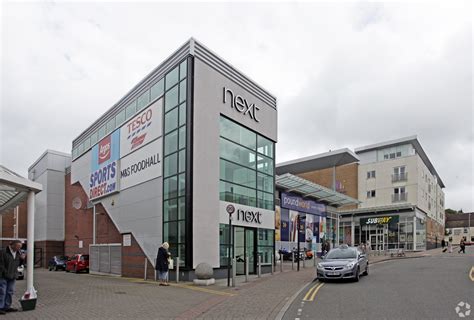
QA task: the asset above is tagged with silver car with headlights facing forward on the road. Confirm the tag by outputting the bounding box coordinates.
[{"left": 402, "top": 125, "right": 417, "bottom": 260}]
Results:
[{"left": 316, "top": 245, "right": 369, "bottom": 281}]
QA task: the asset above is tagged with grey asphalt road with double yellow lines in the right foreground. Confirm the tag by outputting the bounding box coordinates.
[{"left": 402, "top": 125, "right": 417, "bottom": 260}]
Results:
[{"left": 283, "top": 247, "right": 474, "bottom": 320}]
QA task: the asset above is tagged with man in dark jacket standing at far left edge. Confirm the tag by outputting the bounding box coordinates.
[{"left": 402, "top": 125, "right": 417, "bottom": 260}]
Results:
[{"left": 0, "top": 240, "right": 25, "bottom": 314}]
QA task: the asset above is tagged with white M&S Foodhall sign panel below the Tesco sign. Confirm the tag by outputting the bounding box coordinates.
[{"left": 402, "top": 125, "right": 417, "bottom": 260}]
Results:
[{"left": 120, "top": 138, "right": 163, "bottom": 190}]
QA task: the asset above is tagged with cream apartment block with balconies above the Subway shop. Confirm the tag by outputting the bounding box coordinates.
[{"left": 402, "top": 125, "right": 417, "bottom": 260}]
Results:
[{"left": 340, "top": 136, "right": 445, "bottom": 250}]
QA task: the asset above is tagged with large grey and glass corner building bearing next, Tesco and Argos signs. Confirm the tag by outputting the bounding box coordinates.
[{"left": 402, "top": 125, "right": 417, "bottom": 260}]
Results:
[{"left": 70, "top": 39, "right": 277, "bottom": 279}]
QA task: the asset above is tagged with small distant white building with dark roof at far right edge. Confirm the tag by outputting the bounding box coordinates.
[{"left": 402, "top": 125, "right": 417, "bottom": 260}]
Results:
[{"left": 445, "top": 212, "right": 474, "bottom": 244}]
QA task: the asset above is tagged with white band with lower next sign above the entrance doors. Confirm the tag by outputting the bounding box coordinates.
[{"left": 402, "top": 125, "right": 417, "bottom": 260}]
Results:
[{"left": 219, "top": 201, "right": 275, "bottom": 229}]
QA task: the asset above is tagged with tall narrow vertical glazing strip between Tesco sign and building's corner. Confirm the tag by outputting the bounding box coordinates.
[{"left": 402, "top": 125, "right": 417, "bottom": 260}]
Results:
[{"left": 161, "top": 61, "right": 187, "bottom": 266}]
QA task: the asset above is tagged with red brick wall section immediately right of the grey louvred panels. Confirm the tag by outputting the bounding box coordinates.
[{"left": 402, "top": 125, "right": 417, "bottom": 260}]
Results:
[{"left": 122, "top": 234, "right": 154, "bottom": 279}]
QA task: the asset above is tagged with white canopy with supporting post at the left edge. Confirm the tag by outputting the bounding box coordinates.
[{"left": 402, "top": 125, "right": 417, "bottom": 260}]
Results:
[{"left": 0, "top": 165, "right": 43, "bottom": 298}]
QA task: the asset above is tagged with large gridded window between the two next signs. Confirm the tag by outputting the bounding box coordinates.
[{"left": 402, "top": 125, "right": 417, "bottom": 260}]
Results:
[{"left": 220, "top": 116, "right": 275, "bottom": 210}]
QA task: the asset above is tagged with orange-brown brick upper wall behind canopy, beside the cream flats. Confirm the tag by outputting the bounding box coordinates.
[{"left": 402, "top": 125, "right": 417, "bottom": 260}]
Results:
[{"left": 297, "top": 163, "right": 359, "bottom": 210}]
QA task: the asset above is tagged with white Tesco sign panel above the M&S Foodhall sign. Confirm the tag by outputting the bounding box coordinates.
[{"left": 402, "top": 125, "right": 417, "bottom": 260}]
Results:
[{"left": 120, "top": 99, "right": 163, "bottom": 158}]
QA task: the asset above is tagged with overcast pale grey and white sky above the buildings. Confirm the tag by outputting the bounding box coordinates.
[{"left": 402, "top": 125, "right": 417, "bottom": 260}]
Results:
[{"left": 0, "top": 1, "right": 474, "bottom": 212}]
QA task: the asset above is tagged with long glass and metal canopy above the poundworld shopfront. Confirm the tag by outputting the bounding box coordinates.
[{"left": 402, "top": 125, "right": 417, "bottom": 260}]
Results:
[{"left": 275, "top": 173, "right": 360, "bottom": 207}]
